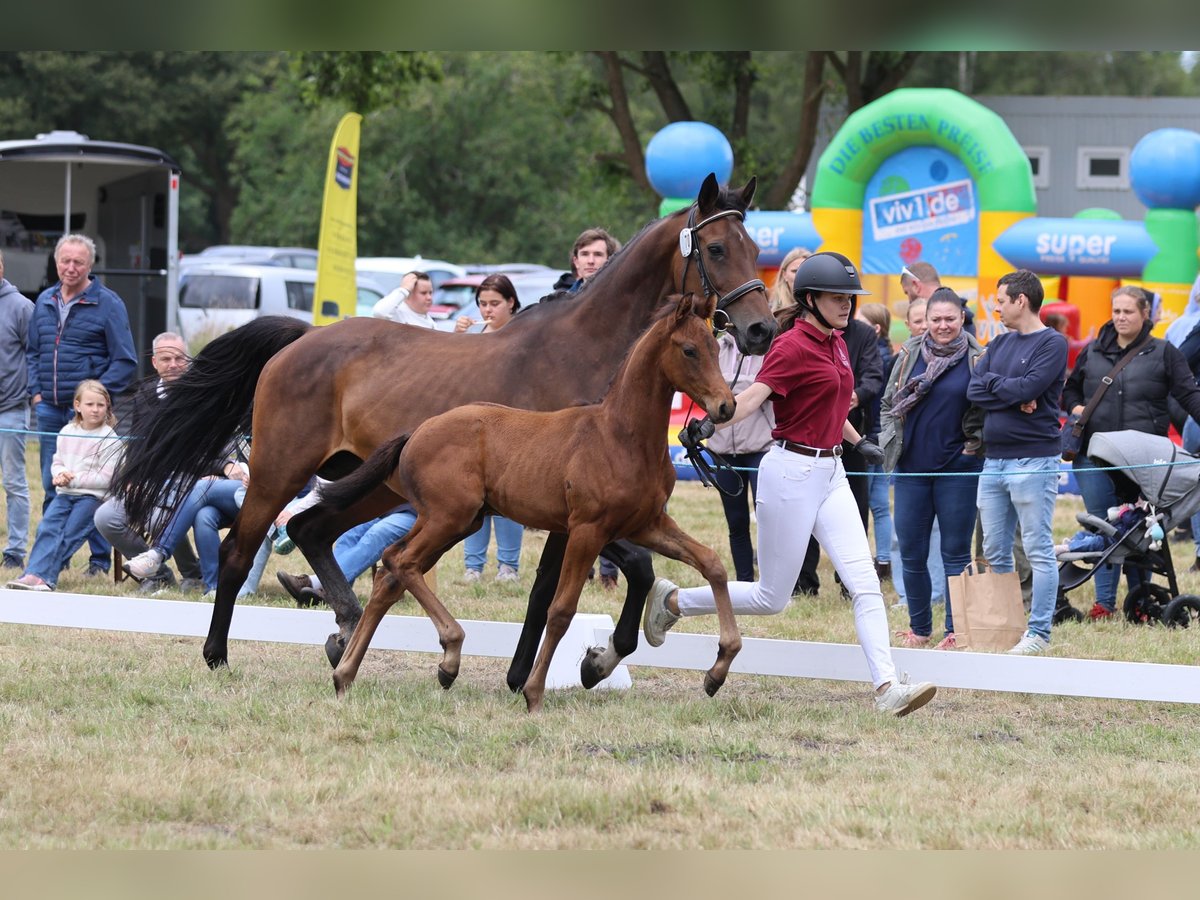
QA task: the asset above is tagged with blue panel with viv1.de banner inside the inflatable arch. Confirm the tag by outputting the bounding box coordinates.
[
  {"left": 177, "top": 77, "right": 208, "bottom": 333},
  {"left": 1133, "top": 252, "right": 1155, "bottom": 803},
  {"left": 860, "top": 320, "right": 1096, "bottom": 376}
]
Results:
[{"left": 862, "top": 146, "right": 979, "bottom": 276}]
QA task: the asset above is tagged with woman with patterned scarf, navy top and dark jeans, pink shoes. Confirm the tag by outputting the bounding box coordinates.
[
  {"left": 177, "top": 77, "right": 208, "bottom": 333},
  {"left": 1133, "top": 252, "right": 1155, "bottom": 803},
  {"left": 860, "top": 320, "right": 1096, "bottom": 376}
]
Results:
[{"left": 880, "top": 288, "right": 984, "bottom": 650}]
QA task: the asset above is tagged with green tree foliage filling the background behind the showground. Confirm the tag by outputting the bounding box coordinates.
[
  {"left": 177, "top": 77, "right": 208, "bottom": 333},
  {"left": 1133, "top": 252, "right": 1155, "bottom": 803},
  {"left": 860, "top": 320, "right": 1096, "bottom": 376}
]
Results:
[{"left": 0, "top": 50, "right": 1200, "bottom": 263}]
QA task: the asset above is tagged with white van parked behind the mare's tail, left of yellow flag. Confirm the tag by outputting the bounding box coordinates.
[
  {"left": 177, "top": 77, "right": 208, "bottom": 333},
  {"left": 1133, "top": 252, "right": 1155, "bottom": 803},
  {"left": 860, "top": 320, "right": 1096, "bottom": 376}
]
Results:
[{"left": 179, "top": 263, "right": 385, "bottom": 354}]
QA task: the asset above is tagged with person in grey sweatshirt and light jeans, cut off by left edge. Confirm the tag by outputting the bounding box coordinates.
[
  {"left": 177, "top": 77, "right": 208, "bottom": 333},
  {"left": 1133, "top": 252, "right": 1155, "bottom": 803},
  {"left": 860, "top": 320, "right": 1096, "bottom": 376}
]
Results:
[{"left": 0, "top": 253, "right": 34, "bottom": 570}]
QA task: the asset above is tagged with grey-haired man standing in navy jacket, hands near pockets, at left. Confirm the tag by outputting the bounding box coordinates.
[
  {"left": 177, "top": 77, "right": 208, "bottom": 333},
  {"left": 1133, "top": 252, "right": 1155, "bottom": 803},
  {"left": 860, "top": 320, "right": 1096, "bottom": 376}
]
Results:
[{"left": 25, "top": 234, "right": 137, "bottom": 575}]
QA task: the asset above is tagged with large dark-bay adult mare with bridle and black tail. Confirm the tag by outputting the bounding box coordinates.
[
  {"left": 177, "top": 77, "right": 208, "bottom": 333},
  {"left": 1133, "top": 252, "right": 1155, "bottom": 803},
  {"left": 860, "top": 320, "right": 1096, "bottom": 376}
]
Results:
[{"left": 116, "top": 175, "right": 776, "bottom": 689}]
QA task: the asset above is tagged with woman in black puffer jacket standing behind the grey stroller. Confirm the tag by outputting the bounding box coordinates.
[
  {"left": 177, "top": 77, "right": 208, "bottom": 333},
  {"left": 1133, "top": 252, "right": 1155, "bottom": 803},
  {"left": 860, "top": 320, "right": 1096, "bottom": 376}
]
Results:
[{"left": 1062, "top": 286, "right": 1200, "bottom": 619}]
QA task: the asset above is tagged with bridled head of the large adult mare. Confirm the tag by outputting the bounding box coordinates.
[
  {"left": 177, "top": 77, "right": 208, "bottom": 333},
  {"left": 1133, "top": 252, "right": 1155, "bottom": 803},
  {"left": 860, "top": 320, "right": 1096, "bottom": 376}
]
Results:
[{"left": 676, "top": 173, "right": 778, "bottom": 355}]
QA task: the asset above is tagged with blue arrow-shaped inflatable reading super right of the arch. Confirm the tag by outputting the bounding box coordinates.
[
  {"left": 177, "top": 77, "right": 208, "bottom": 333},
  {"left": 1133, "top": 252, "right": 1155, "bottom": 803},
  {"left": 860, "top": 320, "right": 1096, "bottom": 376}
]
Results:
[{"left": 992, "top": 218, "right": 1158, "bottom": 277}]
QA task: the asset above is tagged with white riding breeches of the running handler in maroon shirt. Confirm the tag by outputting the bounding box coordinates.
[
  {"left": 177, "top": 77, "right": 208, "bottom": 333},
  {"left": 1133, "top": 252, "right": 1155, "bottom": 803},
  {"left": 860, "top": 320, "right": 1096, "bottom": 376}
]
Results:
[{"left": 678, "top": 446, "right": 896, "bottom": 688}]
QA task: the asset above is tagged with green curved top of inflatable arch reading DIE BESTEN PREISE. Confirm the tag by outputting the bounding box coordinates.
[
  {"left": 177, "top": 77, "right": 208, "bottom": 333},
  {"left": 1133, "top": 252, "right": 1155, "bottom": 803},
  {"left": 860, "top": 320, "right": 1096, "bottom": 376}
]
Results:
[{"left": 812, "top": 88, "right": 1037, "bottom": 214}]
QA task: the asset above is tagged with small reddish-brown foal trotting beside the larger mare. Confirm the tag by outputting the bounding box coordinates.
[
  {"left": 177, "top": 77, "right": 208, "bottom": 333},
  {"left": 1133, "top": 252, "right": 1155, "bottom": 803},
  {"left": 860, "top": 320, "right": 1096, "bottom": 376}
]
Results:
[{"left": 326, "top": 295, "right": 742, "bottom": 712}]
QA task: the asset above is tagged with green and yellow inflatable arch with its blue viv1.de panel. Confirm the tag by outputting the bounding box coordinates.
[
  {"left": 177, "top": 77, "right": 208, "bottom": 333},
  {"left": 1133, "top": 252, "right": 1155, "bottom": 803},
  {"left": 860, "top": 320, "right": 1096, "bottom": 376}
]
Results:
[{"left": 812, "top": 88, "right": 1037, "bottom": 338}]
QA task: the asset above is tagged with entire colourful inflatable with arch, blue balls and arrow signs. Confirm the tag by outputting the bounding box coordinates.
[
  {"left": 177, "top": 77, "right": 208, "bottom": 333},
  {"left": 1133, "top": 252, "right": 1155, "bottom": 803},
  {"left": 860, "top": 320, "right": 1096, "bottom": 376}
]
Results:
[{"left": 646, "top": 88, "right": 1200, "bottom": 341}]
